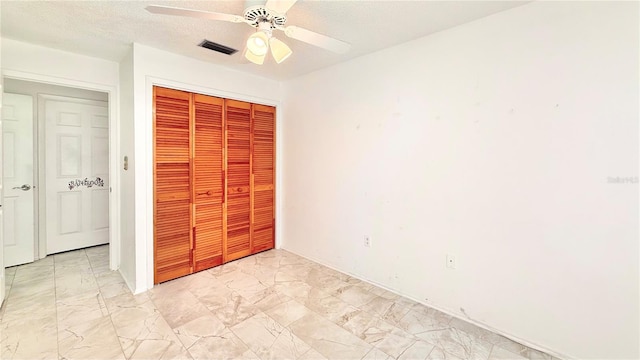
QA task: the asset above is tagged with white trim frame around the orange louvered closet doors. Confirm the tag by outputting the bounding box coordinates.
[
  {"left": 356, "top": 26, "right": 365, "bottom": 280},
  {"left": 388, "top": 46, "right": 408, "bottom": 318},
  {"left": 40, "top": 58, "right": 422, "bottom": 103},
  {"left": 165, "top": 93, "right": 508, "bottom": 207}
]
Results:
[{"left": 145, "top": 76, "right": 283, "bottom": 290}]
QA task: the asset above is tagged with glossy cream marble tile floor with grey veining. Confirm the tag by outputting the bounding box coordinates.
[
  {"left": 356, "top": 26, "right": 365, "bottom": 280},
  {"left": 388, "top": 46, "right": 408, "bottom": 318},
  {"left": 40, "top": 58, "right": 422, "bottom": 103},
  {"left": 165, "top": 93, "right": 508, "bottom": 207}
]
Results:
[{"left": 0, "top": 246, "right": 554, "bottom": 360}]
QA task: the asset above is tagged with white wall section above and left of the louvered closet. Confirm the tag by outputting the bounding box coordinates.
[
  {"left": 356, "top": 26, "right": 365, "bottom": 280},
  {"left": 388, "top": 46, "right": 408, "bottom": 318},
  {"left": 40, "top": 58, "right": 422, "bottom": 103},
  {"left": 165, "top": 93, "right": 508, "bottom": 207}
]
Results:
[{"left": 129, "top": 44, "right": 281, "bottom": 292}]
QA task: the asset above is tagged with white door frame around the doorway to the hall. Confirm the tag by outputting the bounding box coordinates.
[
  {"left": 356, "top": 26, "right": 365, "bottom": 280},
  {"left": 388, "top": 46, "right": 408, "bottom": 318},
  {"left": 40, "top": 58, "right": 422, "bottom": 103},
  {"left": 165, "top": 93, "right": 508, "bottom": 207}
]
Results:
[{"left": 2, "top": 70, "right": 121, "bottom": 270}]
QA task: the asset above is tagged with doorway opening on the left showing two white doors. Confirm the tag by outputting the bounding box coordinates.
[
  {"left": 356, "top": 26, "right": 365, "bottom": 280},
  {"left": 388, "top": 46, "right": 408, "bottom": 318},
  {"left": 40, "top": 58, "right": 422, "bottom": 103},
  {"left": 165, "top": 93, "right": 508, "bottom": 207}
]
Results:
[{"left": 3, "top": 78, "right": 112, "bottom": 268}]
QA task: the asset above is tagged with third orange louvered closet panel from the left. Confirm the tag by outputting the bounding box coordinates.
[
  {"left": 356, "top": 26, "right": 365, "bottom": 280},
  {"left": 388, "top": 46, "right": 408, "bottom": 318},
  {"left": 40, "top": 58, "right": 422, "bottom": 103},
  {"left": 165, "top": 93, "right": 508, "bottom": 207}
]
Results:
[{"left": 225, "top": 100, "right": 251, "bottom": 262}]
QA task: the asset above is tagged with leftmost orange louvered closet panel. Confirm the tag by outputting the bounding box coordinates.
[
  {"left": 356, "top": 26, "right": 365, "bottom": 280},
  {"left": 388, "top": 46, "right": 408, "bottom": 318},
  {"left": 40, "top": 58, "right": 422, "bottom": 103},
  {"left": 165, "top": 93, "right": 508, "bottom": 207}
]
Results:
[{"left": 153, "top": 87, "right": 191, "bottom": 283}]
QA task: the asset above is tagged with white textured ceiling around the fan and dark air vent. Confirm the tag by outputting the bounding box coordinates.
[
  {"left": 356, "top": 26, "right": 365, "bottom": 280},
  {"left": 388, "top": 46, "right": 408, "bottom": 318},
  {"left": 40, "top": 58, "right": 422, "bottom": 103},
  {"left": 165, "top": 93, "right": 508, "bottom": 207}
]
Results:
[{"left": 0, "top": 0, "right": 527, "bottom": 80}]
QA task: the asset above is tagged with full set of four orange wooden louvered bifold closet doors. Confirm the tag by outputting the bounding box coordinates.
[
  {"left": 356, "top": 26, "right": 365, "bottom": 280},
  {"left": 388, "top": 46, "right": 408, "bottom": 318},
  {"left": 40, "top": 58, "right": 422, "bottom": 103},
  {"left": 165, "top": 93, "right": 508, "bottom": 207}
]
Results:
[{"left": 153, "top": 87, "right": 275, "bottom": 283}]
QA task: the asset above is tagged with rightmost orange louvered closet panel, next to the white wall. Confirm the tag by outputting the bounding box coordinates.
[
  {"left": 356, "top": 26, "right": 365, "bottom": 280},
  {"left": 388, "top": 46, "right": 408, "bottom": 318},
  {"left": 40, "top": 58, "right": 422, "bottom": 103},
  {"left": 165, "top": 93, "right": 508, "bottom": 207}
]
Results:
[{"left": 251, "top": 104, "right": 275, "bottom": 253}]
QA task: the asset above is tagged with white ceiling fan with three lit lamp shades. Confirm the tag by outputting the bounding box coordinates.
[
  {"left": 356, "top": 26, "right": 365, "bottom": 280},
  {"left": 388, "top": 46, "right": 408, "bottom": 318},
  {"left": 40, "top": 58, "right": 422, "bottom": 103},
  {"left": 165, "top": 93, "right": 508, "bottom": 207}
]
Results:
[{"left": 146, "top": 0, "right": 351, "bottom": 65}]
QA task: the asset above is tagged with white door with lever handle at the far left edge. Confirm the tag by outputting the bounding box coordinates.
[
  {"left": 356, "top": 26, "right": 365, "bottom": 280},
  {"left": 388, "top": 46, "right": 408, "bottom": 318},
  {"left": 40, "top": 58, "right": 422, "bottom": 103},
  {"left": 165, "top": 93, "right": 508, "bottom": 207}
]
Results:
[{"left": 2, "top": 93, "right": 35, "bottom": 266}]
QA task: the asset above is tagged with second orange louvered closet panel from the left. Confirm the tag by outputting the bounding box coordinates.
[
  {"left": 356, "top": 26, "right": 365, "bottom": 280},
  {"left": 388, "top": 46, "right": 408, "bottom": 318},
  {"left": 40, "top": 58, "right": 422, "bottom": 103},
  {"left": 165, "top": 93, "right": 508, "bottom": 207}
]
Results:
[{"left": 193, "top": 94, "right": 224, "bottom": 271}]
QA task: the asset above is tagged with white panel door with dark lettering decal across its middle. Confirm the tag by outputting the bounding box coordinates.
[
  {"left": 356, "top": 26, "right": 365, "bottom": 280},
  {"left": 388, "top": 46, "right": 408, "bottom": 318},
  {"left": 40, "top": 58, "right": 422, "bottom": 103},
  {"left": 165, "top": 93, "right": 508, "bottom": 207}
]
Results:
[{"left": 42, "top": 95, "right": 109, "bottom": 254}]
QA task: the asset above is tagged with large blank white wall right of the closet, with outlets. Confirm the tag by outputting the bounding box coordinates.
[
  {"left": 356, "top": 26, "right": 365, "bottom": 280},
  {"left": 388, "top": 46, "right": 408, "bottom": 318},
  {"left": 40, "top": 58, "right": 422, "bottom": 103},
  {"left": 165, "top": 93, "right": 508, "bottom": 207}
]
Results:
[{"left": 282, "top": 2, "right": 640, "bottom": 359}]
